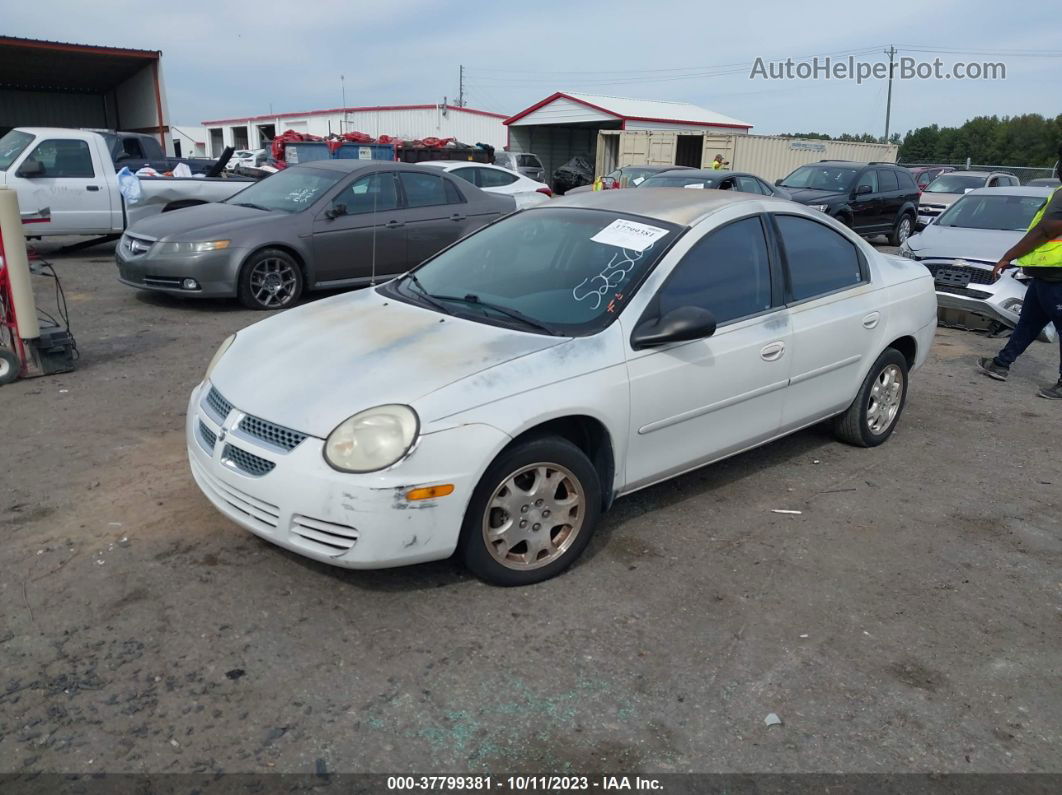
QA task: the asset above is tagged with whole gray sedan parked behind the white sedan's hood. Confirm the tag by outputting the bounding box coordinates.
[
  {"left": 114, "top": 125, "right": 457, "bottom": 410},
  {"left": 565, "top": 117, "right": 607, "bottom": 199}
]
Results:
[{"left": 115, "top": 160, "right": 516, "bottom": 309}]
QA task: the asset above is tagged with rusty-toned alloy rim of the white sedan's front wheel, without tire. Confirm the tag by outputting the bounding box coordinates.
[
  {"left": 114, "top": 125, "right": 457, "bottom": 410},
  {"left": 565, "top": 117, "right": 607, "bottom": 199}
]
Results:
[{"left": 482, "top": 463, "right": 586, "bottom": 570}]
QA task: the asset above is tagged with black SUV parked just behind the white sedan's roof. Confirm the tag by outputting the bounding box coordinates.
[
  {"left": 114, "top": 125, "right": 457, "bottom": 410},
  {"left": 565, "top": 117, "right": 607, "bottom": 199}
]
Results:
[{"left": 775, "top": 160, "right": 919, "bottom": 245}]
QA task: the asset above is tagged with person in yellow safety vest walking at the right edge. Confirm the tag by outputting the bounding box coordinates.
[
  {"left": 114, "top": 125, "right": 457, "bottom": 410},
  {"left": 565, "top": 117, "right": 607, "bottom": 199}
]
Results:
[{"left": 977, "top": 148, "right": 1062, "bottom": 400}]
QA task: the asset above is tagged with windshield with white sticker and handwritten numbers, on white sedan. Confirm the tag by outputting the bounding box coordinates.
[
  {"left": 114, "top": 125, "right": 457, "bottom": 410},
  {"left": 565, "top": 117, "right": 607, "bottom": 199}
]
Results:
[{"left": 389, "top": 208, "right": 680, "bottom": 336}]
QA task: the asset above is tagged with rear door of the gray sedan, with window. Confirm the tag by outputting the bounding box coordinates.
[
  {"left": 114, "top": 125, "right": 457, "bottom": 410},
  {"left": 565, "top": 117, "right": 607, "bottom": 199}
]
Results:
[{"left": 398, "top": 171, "right": 473, "bottom": 267}]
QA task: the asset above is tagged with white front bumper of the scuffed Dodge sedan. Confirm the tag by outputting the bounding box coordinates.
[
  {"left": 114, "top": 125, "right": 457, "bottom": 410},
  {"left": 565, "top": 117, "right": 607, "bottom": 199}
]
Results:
[{"left": 185, "top": 382, "right": 510, "bottom": 569}]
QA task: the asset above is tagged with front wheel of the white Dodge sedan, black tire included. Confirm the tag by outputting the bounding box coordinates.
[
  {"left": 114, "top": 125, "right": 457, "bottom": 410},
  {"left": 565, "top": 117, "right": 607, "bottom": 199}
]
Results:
[{"left": 458, "top": 436, "right": 601, "bottom": 586}]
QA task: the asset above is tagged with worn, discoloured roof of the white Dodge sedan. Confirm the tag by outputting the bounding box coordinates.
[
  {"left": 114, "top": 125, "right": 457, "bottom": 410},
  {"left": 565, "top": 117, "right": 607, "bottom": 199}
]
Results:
[{"left": 547, "top": 188, "right": 792, "bottom": 226}]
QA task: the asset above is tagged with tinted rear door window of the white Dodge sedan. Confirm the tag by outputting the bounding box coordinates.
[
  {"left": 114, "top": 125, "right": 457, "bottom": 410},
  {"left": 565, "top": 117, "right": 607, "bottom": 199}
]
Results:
[{"left": 774, "top": 214, "right": 864, "bottom": 301}]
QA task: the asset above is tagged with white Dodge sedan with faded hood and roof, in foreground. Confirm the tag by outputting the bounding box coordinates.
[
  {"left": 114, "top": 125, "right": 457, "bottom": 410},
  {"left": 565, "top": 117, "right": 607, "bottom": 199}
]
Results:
[{"left": 187, "top": 189, "right": 937, "bottom": 585}]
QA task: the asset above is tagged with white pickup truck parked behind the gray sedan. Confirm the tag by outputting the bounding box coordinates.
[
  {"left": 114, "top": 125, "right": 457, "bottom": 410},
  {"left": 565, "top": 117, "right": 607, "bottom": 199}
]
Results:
[{"left": 0, "top": 127, "right": 255, "bottom": 237}]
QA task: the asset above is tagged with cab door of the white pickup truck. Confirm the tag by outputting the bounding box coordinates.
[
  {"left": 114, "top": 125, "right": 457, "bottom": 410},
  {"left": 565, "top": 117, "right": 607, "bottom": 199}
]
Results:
[{"left": 11, "top": 138, "right": 110, "bottom": 235}]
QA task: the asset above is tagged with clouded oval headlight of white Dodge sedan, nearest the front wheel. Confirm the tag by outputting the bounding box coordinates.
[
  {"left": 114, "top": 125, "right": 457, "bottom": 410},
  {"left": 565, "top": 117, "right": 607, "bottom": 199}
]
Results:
[{"left": 325, "top": 404, "right": 421, "bottom": 472}]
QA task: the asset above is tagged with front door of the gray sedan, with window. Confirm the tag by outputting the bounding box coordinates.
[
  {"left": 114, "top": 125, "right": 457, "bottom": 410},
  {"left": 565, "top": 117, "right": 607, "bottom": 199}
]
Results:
[{"left": 313, "top": 171, "right": 407, "bottom": 284}]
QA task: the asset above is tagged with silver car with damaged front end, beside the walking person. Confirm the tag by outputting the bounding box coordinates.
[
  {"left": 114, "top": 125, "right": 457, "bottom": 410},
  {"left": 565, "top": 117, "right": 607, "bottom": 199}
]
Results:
[{"left": 900, "top": 185, "right": 1056, "bottom": 342}]
